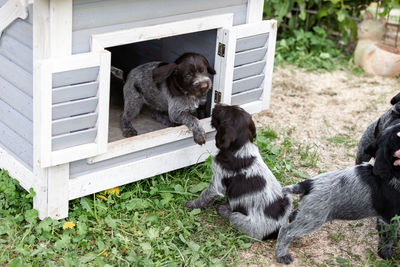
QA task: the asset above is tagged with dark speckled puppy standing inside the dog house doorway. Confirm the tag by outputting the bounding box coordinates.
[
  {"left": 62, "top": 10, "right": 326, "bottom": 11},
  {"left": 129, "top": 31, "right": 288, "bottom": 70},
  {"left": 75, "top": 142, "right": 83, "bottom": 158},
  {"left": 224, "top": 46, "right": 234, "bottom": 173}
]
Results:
[{"left": 121, "top": 53, "right": 215, "bottom": 145}]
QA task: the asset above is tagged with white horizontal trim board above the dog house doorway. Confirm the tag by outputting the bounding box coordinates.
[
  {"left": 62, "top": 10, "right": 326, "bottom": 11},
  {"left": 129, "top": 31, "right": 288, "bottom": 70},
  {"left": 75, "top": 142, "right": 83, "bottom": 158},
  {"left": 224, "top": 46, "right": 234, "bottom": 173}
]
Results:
[{"left": 91, "top": 14, "right": 233, "bottom": 51}]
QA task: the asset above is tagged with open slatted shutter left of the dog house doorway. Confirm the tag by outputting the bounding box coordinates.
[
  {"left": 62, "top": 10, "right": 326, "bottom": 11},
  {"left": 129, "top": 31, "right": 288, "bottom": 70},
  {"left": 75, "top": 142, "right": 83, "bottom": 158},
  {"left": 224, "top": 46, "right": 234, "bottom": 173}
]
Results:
[{"left": 35, "top": 50, "right": 111, "bottom": 168}]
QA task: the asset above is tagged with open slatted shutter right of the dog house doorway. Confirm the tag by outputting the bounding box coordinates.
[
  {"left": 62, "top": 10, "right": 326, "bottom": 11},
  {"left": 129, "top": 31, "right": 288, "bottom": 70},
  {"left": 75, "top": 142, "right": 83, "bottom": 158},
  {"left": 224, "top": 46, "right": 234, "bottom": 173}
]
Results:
[{"left": 220, "top": 20, "right": 277, "bottom": 113}]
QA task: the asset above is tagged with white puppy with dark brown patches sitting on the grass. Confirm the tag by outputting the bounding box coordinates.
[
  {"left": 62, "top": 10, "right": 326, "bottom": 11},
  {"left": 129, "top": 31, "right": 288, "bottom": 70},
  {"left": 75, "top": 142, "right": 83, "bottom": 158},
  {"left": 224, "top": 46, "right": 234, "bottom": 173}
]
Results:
[{"left": 185, "top": 105, "right": 292, "bottom": 240}]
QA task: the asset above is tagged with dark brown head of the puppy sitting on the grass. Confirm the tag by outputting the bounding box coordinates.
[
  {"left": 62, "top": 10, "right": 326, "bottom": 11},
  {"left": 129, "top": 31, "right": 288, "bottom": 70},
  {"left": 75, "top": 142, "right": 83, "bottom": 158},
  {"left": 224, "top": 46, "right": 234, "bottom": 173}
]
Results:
[{"left": 211, "top": 105, "right": 256, "bottom": 151}]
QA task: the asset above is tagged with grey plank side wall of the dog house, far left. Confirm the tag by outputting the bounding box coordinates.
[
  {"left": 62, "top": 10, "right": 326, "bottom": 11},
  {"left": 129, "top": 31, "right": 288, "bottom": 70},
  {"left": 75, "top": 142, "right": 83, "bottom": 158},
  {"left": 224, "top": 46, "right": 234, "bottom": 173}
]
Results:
[{"left": 0, "top": 0, "right": 33, "bottom": 169}]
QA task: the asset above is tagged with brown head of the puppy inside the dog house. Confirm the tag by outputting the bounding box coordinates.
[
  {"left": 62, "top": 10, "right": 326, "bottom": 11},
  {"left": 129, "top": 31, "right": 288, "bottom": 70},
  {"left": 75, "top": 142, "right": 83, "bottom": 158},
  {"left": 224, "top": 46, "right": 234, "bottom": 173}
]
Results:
[{"left": 153, "top": 53, "right": 216, "bottom": 98}]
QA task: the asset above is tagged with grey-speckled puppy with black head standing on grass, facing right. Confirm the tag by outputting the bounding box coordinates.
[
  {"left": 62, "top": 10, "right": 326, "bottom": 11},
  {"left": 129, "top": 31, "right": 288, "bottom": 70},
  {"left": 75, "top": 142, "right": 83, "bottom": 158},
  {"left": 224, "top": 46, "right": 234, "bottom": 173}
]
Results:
[{"left": 275, "top": 120, "right": 400, "bottom": 264}]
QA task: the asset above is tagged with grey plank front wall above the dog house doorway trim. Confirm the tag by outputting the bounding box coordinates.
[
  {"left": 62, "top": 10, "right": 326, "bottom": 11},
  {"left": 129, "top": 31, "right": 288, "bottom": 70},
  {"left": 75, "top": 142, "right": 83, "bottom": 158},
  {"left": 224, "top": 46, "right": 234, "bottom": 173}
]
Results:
[{"left": 72, "top": 0, "right": 247, "bottom": 54}]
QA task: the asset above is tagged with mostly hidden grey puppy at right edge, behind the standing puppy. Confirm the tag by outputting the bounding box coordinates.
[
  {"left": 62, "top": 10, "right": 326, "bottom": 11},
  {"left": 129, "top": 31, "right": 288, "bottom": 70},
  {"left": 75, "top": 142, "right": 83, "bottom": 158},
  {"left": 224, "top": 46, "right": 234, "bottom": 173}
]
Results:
[{"left": 356, "top": 93, "right": 400, "bottom": 164}]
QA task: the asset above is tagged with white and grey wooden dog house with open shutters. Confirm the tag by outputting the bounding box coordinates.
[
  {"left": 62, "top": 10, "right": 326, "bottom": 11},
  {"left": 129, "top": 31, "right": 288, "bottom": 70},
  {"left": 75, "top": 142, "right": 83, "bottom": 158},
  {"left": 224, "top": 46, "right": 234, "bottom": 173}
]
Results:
[{"left": 0, "top": 0, "right": 277, "bottom": 219}]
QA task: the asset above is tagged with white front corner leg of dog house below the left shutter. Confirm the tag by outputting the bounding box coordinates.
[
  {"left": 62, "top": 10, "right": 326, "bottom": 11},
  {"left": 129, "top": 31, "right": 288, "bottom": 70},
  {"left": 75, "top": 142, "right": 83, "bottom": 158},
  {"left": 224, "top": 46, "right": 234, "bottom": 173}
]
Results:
[{"left": 47, "top": 164, "right": 69, "bottom": 220}]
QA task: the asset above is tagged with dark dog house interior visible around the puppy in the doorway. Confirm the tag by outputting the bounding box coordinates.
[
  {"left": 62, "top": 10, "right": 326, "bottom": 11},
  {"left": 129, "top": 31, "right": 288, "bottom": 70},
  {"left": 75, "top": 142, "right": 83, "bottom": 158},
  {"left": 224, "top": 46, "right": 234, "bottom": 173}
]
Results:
[{"left": 107, "top": 30, "right": 217, "bottom": 142}]
